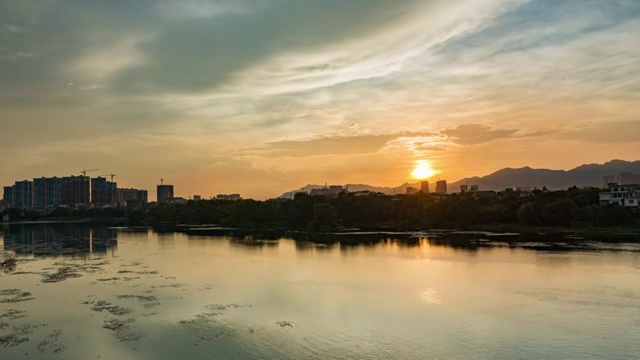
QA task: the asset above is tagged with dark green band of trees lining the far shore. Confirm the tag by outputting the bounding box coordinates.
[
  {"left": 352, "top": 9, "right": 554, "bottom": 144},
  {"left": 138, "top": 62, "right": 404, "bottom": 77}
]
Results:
[{"left": 2, "top": 187, "right": 640, "bottom": 238}]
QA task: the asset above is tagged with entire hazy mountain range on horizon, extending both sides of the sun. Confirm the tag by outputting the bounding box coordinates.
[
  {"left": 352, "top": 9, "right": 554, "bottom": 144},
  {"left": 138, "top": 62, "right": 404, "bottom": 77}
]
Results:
[{"left": 280, "top": 160, "right": 640, "bottom": 199}]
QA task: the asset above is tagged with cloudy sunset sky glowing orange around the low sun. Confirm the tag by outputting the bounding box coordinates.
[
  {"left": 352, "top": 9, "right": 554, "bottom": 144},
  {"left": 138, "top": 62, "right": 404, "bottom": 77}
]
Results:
[{"left": 0, "top": 0, "right": 640, "bottom": 199}]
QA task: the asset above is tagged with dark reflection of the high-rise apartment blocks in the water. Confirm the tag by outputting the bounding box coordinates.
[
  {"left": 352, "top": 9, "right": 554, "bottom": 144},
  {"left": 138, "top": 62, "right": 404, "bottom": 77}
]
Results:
[{"left": 4, "top": 224, "right": 117, "bottom": 257}]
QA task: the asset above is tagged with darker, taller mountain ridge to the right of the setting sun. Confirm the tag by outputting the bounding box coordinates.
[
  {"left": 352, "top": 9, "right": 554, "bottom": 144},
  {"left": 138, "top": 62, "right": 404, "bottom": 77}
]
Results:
[{"left": 448, "top": 160, "right": 640, "bottom": 192}]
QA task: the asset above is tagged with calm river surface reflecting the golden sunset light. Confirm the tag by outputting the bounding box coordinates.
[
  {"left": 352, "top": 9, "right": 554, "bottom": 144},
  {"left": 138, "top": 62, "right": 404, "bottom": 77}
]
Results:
[{"left": 0, "top": 224, "right": 640, "bottom": 359}]
